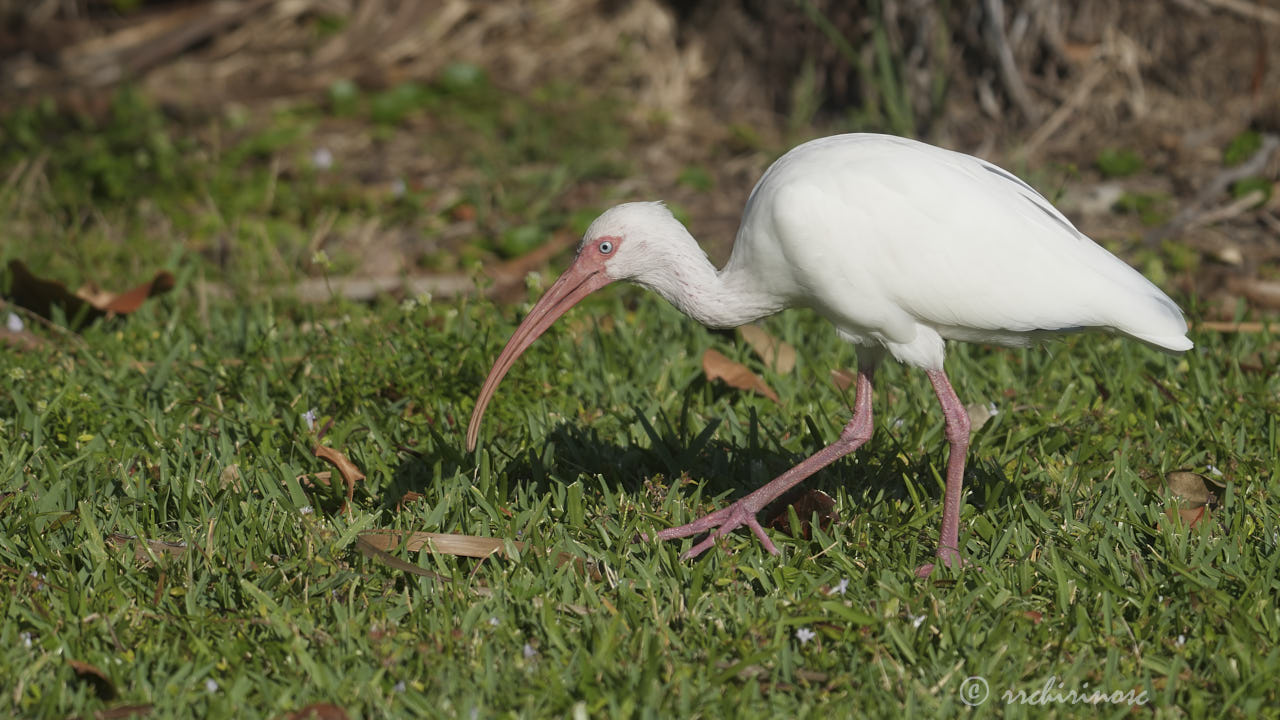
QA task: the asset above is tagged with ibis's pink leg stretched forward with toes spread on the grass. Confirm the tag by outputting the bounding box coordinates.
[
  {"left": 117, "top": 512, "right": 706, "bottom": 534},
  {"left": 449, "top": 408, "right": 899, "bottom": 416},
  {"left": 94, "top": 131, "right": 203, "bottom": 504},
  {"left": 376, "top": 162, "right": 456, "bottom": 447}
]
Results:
[{"left": 658, "top": 364, "right": 875, "bottom": 559}]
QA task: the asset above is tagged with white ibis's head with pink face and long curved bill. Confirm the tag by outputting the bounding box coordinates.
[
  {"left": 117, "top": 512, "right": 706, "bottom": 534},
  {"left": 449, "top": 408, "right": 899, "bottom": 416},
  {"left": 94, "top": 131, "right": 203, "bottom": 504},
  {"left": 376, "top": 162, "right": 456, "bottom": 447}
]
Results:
[{"left": 467, "top": 202, "right": 696, "bottom": 450}]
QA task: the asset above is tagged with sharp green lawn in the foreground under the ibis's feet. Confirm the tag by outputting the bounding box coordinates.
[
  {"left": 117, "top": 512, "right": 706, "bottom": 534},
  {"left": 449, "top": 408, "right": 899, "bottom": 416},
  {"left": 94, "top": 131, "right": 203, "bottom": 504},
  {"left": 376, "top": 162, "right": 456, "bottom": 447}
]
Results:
[{"left": 0, "top": 278, "right": 1280, "bottom": 717}]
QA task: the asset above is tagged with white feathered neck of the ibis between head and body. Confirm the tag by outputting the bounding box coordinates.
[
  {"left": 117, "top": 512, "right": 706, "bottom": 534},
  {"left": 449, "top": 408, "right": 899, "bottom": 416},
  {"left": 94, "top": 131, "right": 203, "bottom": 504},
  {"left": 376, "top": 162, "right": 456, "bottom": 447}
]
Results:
[{"left": 637, "top": 237, "right": 786, "bottom": 328}]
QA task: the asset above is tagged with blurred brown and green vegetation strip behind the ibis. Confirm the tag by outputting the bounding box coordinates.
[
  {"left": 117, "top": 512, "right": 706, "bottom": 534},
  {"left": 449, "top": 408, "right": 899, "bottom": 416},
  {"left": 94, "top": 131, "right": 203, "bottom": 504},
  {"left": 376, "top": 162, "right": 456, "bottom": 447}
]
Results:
[{"left": 0, "top": 0, "right": 1280, "bottom": 318}]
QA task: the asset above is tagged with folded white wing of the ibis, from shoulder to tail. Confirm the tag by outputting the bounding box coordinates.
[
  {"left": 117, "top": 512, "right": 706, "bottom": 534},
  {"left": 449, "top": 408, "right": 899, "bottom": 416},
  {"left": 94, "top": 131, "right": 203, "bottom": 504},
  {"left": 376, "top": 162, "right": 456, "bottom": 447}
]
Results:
[{"left": 768, "top": 138, "right": 1190, "bottom": 350}]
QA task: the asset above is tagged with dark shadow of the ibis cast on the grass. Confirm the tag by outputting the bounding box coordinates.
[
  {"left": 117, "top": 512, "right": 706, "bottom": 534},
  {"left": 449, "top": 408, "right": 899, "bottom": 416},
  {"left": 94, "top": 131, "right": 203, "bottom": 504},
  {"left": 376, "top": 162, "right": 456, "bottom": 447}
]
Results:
[{"left": 381, "top": 392, "right": 1023, "bottom": 543}]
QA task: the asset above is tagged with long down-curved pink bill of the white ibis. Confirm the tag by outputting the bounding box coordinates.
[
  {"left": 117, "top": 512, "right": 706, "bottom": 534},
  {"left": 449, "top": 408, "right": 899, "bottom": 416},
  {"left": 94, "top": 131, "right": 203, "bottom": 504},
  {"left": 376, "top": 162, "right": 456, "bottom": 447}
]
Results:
[{"left": 467, "top": 255, "right": 613, "bottom": 452}]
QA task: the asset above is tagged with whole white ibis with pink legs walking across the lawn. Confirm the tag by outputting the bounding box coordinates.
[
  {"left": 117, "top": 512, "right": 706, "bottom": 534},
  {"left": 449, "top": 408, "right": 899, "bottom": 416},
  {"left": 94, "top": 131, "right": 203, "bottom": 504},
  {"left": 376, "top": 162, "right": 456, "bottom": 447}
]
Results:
[{"left": 467, "top": 135, "right": 1192, "bottom": 575}]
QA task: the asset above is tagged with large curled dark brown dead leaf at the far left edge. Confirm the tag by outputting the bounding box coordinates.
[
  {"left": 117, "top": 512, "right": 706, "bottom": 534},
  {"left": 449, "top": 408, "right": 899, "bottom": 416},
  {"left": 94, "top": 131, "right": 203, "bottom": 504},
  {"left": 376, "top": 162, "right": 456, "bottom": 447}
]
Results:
[{"left": 9, "top": 260, "right": 175, "bottom": 320}]
